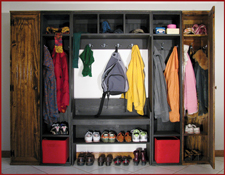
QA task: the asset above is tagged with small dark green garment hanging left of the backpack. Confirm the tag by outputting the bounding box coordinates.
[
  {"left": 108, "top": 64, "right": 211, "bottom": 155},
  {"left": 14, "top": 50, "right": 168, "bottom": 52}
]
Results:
[{"left": 80, "top": 44, "right": 95, "bottom": 77}]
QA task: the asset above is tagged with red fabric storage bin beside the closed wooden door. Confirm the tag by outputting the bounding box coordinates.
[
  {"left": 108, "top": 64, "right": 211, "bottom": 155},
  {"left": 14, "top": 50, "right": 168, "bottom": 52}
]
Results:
[{"left": 42, "top": 138, "right": 69, "bottom": 164}]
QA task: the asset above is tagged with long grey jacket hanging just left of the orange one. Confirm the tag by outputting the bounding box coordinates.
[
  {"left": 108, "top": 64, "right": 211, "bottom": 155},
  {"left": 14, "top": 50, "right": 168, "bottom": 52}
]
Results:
[{"left": 153, "top": 46, "right": 171, "bottom": 122}]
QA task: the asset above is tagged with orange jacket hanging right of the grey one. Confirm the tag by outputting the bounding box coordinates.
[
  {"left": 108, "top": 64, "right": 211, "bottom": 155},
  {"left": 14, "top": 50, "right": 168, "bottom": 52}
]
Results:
[{"left": 164, "top": 46, "right": 180, "bottom": 122}]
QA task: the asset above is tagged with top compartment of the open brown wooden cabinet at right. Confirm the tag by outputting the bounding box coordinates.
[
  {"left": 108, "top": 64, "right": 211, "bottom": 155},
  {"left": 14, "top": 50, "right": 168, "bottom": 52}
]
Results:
[{"left": 182, "top": 11, "right": 209, "bottom": 35}]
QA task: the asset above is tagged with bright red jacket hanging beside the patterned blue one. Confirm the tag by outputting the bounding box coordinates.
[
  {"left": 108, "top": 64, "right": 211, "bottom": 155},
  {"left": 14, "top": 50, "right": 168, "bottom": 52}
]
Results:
[{"left": 52, "top": 47, "right": 70, "bottom": 113}]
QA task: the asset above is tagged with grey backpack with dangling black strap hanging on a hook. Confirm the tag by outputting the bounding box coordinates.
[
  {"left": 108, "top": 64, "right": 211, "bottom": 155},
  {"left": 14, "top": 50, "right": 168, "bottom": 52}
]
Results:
[{"left": 95, "top": 50, "right": 129, "bottom": 117}]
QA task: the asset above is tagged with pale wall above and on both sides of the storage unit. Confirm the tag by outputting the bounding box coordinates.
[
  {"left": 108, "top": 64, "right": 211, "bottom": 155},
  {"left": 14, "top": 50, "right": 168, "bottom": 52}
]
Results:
[{"left": 1, "top": 1, "right": 224, "bottom": 151}]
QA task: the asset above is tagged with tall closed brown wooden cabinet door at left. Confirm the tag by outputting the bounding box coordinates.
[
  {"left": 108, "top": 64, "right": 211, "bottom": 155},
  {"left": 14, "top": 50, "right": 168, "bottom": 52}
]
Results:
[{"left": 10, "top": 12, "right": 40, "bottom": 164}]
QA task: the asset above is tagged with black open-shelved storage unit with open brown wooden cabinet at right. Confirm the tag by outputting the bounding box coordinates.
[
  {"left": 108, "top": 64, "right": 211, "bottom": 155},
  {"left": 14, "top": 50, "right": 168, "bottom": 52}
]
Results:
[{"left": 11, "top": 7, "right": 215, "bottom": 168}]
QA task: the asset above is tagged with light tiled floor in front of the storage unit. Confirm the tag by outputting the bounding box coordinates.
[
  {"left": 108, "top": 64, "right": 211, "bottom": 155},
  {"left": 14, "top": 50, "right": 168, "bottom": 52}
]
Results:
[{"left": 2, "top": 157, "right": 224, "bottom": 174}]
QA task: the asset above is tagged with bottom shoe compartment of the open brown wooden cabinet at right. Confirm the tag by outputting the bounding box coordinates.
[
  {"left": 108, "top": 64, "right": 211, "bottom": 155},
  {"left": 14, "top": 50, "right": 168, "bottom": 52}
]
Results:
[{"left": 183, "top": 135, "right": 209, "bottom": 163}]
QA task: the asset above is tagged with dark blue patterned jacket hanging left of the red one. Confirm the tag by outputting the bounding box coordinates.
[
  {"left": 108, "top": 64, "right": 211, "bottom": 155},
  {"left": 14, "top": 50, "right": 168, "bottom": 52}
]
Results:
[{"left": 43, "top": 46, "right": 59, "bottom": 126}]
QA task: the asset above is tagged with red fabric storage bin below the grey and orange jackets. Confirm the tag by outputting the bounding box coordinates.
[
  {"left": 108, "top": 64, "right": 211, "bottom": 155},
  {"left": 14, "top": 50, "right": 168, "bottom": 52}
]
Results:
[{"left": 155, "top": 137, "right": 180, "bottom": 163}]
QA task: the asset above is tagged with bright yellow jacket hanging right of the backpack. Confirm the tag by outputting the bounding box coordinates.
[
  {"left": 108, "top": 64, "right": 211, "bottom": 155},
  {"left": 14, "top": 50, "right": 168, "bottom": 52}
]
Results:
[{"left": 121, "top": 45, "right": 146, "bottom": 115}]
